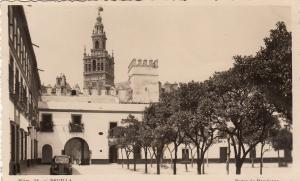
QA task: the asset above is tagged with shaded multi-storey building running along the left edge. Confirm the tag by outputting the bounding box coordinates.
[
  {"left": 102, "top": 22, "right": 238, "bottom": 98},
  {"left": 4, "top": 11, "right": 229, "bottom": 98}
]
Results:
[{"left": 8, "top": 6, "right": 41, "bottom": 174}]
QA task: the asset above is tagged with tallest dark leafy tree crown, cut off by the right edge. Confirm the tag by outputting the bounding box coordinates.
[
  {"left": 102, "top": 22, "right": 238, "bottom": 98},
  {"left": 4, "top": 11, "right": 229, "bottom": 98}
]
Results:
[{"left": 234, "top": 22, "right": 292, "bottom": 124}]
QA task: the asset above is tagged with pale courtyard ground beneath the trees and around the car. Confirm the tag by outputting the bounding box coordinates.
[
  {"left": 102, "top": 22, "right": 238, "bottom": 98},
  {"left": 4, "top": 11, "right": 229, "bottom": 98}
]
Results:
[{"left": 21, "top": 163, "right": 293, "bottom": 175}]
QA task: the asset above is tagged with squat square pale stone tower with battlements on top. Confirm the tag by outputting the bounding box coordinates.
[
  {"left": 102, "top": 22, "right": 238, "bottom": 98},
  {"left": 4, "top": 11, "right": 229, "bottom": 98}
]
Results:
[{"left": 128, "top": 59, "right": 159, "bottom": 103}]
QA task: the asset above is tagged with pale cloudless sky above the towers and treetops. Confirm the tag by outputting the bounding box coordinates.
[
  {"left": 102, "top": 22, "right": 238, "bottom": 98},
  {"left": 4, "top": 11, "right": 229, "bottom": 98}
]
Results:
[{"left": 24, "top": 5, "right": 291, "bottom": 87}]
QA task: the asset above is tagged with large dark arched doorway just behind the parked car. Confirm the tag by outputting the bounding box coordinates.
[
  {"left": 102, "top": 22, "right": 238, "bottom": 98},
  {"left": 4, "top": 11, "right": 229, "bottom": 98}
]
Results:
[{"left": 64, "top": 137, "right": 90, "bottom": 165}]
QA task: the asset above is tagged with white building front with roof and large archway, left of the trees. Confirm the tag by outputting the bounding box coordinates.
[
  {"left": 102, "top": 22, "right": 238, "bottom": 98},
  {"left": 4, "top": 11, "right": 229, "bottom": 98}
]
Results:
[{"left": 38, "top": 95, "right": 146, "bottom": 164}]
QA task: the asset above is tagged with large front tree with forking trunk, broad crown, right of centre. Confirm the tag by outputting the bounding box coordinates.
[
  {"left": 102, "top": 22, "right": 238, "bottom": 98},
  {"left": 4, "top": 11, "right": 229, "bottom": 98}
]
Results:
[{"left": 211, "top": 69, "right": 278, "bottom": 174}]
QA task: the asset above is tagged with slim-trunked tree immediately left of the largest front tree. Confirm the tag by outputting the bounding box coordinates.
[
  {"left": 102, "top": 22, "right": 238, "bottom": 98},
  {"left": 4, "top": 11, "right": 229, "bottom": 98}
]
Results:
[{"left": 178, "top": 81, "right": 218, "bottom": 174}]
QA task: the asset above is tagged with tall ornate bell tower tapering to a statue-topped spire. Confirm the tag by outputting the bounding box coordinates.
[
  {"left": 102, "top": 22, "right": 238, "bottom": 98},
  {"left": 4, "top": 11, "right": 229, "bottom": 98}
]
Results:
[{"left": 83, "top": 7, "right": 114, "bottom": 95}]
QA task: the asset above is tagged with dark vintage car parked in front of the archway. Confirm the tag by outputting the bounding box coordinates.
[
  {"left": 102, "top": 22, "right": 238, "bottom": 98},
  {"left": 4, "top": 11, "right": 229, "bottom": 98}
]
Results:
[{"left": 50, "top": 155, "right": 72, "bottom": 175}]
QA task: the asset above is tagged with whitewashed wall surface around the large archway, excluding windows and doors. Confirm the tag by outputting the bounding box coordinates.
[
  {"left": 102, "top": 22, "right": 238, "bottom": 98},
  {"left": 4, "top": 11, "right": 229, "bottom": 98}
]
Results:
[{"left": 38, "top": 111, "right": 141, "bottom": 163}]
